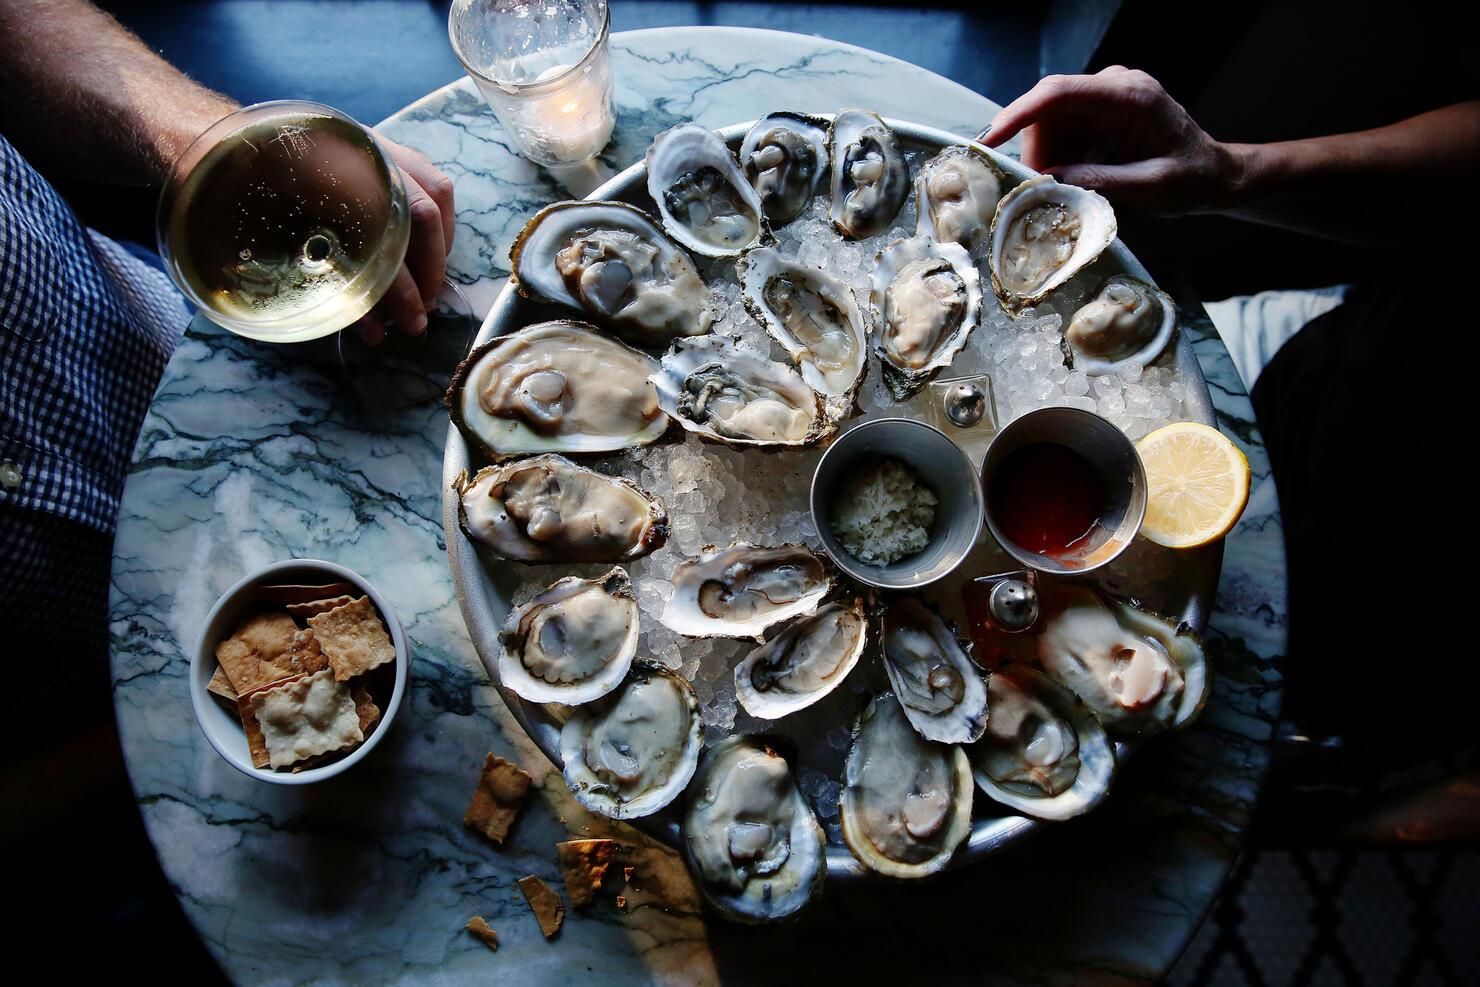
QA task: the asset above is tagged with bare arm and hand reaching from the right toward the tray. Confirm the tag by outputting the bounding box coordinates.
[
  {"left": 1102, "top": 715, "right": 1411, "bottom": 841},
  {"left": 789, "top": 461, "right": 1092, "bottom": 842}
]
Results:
[{"left": 987, "top": 65, "right": 1480, "bottom": 246}]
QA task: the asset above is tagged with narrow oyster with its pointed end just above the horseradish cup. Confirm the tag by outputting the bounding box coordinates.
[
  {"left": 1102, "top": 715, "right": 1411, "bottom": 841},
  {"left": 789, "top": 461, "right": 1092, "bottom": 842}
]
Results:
[{"left": 736, "top": 247, "right": 869, "bottom": 417}]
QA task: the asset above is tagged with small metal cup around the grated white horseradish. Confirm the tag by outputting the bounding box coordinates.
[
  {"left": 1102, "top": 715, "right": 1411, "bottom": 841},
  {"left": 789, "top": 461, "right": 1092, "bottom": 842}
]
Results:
[{"left": 811, "top": 419, "right": 981, "bottom": 589}]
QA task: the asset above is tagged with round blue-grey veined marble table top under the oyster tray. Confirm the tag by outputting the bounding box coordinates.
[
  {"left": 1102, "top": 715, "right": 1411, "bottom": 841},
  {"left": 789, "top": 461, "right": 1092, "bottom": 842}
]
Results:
[{"left": 111, "top": 28, "right": 1285, "bottom": 984}]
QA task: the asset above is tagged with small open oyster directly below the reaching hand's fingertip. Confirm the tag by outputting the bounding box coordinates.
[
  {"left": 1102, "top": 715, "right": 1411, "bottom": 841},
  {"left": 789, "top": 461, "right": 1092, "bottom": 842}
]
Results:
[{"left": 915, "top": 144, "right": 1011, "bottom": 255}]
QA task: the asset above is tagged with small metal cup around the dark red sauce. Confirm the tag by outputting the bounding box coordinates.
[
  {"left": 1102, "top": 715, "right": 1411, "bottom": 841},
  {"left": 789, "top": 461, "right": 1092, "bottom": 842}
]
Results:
[{"left": 981, "top": 408, "right": 1146, "bottom": 576}]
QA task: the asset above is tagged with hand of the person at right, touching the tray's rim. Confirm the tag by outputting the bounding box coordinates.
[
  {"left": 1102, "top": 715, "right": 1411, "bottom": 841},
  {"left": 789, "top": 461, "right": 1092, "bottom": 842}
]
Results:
[{"left": 984, "top": 65, "right": 1240, "bottom": 215}]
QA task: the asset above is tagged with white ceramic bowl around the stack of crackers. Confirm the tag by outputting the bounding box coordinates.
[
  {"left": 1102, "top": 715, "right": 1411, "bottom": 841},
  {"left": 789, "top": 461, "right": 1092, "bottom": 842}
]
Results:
[{"left": 189, "top": 559, "right": 411, "bottom": 784}]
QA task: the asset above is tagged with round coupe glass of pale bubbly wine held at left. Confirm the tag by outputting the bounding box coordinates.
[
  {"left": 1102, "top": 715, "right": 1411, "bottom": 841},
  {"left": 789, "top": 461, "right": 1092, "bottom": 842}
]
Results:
[{"left": 155, "top": 99, "right": 411, "bottom": 342}]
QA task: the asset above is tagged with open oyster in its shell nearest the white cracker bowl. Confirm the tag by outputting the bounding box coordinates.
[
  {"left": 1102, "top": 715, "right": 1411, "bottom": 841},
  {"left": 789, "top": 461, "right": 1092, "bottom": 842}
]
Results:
[{"left": 499, "top": 567, "right": 638, "bottom": 706}]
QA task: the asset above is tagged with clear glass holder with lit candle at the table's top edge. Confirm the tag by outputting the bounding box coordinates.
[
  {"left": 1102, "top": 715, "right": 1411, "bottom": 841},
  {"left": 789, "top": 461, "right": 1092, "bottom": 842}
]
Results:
[{"left": 447, "top": 0, "right": 614, "bottom": 167}]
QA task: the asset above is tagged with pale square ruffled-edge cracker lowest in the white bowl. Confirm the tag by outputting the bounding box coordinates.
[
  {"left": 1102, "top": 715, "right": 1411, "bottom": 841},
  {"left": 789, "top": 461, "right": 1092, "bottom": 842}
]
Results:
[{"left": 252, "top": 669, "right": 364, "bottom": 768}]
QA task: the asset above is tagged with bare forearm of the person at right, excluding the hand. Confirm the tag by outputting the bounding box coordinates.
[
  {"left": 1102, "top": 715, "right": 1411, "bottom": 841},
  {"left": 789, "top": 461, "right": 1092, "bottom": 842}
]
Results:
[{"left": 1221, "top": 101, "right": 1480, "bottom": 249}]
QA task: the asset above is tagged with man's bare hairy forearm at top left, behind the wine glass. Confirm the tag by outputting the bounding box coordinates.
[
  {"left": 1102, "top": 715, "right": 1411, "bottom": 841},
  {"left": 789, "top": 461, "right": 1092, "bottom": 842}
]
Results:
[{"left": 0, "top": 0, "right": 235, "bottom": 185}]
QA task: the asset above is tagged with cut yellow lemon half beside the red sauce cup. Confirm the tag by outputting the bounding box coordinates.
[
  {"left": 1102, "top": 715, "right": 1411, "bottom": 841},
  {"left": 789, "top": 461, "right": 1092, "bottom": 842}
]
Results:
[{"left": 1135, "top": 422, "right": 1249, "bottom": 549}]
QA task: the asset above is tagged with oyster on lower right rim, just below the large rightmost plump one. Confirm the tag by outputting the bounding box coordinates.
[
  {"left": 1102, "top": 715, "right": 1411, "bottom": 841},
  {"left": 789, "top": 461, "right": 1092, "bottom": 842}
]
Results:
[{"left": 966, "top": 664, "right": 1114, "bottom": 820}]
